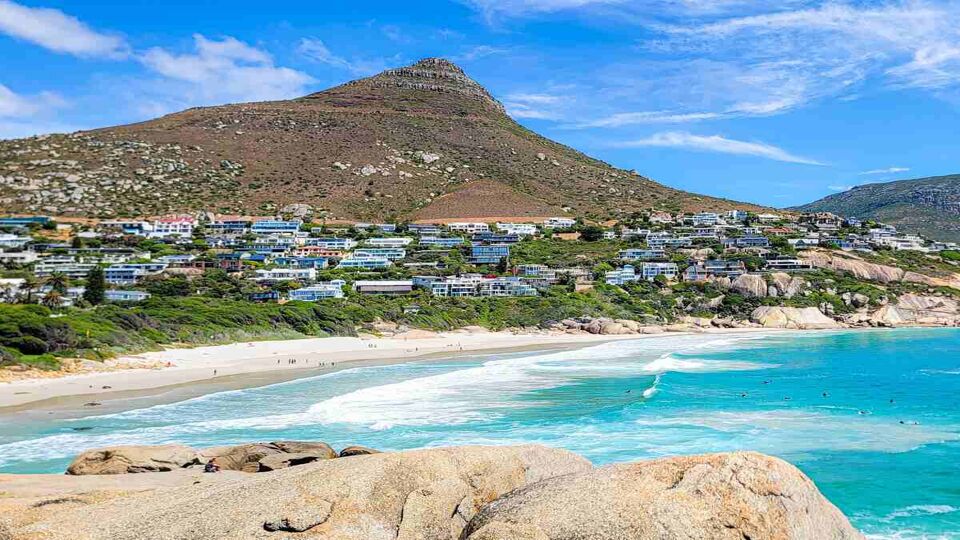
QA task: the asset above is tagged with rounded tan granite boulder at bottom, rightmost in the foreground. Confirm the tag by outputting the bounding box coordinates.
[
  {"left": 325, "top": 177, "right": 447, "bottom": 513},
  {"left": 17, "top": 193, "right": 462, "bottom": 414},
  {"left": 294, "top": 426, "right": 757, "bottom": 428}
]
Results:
[{"left": 463, "top": 452, "right": 864, "bottom": 540}]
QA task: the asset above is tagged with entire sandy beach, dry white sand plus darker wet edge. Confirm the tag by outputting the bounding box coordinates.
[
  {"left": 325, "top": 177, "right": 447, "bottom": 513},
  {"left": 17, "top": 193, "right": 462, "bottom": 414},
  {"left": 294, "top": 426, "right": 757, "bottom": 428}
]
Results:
[{"left": 0, "top": 328, "right": 776, "bottom": 417}]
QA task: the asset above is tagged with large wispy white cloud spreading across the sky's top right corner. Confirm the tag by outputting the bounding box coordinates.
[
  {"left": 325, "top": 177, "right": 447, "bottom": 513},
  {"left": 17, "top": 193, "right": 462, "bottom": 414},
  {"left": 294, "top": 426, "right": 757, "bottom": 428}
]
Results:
[{"left": 658, "top": 0, "right": 960, "bottom": 100}]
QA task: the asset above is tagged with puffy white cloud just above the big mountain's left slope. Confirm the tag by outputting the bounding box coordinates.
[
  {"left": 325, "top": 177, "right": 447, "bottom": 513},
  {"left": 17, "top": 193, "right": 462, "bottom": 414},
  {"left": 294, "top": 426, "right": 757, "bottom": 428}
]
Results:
[{"left": 140, "top": 34, "right": 314, "bottom": 109}]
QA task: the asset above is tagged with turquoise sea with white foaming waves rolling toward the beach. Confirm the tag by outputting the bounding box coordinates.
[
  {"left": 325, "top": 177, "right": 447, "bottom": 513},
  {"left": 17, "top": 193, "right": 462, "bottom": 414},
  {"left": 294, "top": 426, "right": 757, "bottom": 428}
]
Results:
[{"left": 0, "top": 329, "right": 960, "bottom": 538}]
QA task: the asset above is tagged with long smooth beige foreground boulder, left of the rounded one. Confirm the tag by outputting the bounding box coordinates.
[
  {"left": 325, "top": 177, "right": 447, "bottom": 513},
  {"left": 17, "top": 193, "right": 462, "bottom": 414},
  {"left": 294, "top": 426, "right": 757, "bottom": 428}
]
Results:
[{"left": 39, "top": 445, "right": 591, "bottom": 540}]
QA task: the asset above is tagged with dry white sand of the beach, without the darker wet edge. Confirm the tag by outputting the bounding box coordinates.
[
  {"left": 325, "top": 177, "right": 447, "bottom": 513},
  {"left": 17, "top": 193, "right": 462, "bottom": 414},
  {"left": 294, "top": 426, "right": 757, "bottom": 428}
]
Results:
[{"left": 0, "top": 331, "right": 655, "bottom": 408}]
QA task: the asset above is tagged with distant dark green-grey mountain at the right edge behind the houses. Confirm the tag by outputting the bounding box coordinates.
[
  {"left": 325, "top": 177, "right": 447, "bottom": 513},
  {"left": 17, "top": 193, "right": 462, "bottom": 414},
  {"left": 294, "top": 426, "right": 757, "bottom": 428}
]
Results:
[{"left": 796, "top": 174, "right": 960, "bottom": 242}]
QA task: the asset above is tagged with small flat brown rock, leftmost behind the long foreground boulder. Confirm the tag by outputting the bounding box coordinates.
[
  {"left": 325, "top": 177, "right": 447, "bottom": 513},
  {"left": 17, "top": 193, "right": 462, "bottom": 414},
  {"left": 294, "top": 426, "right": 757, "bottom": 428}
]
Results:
[{"left": 67, "top": 444, "right": 200, "bottom": 475}]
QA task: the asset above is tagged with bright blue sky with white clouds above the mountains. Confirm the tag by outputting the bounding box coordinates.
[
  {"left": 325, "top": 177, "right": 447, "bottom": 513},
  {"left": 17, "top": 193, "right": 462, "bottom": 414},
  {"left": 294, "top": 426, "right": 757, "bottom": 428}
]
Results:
[{"left": 0, "top": 0, "right": 960, "bottom": 206}]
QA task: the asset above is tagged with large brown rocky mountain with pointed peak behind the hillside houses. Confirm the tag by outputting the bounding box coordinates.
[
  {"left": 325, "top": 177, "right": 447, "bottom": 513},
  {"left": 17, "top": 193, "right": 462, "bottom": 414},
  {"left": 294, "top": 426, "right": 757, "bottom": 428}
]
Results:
[{"left": 0, "top": 58, "right": 756, "bottom": 219}]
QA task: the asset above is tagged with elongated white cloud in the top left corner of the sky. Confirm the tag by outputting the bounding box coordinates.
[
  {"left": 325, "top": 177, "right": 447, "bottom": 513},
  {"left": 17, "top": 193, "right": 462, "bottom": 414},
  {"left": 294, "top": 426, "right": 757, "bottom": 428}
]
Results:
[{"left": 0, "top": 0, "right": 128, "bottom": 58}]
